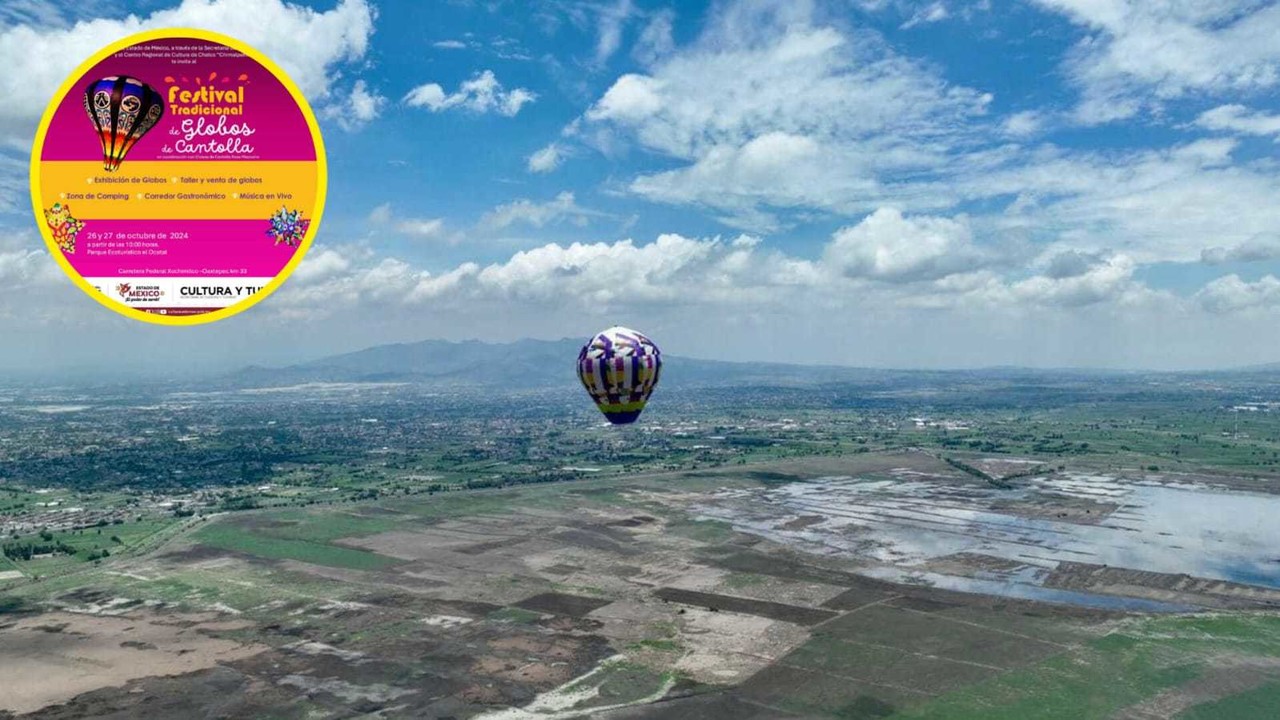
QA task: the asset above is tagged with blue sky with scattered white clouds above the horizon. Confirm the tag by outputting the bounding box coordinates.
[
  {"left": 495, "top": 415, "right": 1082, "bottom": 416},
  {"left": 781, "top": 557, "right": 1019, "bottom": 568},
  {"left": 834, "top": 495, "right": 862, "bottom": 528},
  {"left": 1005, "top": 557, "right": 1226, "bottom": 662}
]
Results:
[{"left": 0, "top": 0, "right": 1280, "bottom": 372}]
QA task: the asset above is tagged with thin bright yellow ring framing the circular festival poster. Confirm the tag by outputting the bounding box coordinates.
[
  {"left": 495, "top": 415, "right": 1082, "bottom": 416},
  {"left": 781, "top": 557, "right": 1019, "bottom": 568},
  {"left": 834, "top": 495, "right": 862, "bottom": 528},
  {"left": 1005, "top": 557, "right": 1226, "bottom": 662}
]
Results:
[{"left": 31, "top": 27, "right": 329, "bottom": 325}]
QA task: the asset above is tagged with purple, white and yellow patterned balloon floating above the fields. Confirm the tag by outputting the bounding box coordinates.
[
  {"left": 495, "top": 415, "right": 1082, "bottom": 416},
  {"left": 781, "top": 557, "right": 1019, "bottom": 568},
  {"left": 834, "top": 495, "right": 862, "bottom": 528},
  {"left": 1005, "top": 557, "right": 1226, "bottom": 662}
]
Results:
[{"left": 577, "top": 325, "right": 662, "bottom": 425}]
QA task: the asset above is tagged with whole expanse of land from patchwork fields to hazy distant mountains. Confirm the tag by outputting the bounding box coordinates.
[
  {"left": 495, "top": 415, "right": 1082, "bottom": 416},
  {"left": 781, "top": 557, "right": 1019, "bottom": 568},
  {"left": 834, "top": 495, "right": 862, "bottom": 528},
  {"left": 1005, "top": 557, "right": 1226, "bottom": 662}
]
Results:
[{"left": 0, "top": 341, "right": 1280, "bottom": 720}]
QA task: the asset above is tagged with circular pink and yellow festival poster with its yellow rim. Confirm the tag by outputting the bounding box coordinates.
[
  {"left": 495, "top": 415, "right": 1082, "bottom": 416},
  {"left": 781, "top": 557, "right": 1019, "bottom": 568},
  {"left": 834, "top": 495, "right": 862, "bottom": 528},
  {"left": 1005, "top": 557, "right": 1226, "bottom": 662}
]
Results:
[{"left": 31, "top": 29, "right": 326, "bottom": 324}]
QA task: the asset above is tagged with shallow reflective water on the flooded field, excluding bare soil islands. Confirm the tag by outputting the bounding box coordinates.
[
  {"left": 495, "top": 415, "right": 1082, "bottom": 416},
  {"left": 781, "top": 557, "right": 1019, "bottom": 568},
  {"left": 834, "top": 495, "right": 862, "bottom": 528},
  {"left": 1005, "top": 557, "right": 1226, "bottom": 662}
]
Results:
[{"left": 699, "top": 470, "right": 1280, "bottom": 609}]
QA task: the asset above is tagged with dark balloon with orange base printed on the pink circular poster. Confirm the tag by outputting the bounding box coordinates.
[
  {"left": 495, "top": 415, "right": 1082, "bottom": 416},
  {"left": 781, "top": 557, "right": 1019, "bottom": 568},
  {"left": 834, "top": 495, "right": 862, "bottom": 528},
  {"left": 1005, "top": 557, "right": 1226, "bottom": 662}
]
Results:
[{"left": 84, "top": 76, "right": 164, "bottom": 172}]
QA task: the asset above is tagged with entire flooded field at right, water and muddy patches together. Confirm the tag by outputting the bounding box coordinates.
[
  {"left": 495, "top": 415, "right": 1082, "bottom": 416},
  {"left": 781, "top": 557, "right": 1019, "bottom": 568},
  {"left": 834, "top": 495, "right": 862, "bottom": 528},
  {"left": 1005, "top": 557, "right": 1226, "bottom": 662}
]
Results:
[{"left": 696, "top": 468, "right": 1280, "bottom": 610}]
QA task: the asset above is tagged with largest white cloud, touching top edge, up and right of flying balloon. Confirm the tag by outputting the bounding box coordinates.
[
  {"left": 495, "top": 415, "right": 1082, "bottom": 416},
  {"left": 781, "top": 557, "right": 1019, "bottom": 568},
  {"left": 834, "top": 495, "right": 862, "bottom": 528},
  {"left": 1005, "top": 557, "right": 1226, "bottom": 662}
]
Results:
[{"left": 570, "top": 1, "right": 991, "bottom": 226}]
